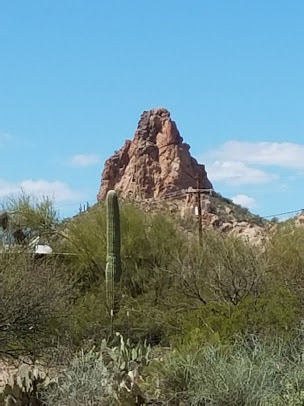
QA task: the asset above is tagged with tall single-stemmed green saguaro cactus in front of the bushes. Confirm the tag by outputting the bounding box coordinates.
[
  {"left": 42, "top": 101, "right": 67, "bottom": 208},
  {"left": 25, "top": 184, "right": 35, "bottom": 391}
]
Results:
[{"left": 106, "top": 190, "right": 121, "bottom": 316}]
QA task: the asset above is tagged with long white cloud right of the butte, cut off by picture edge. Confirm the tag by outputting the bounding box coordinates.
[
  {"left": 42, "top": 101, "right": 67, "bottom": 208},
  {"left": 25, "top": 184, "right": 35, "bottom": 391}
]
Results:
[{"left": 210, "top": 141, "right": 304, "bottom": 169}]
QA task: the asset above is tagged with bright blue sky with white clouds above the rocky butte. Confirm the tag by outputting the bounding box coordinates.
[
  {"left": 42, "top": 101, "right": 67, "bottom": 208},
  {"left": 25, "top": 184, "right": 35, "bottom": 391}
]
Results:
[{"left": 0, "top": 0, "right": 304, "bottom": 216}]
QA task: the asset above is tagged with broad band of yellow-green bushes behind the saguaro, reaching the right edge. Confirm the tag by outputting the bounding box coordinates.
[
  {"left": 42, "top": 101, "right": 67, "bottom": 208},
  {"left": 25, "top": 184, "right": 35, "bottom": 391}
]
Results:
[{"left": 27, "top": 202, "right": 304, "bottom": 354}]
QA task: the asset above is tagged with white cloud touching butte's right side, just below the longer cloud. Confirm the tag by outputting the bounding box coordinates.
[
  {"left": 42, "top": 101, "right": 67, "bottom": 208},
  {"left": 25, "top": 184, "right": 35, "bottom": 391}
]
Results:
[{"left": 207, "top": 161, "right": 277, "bottom": 184}]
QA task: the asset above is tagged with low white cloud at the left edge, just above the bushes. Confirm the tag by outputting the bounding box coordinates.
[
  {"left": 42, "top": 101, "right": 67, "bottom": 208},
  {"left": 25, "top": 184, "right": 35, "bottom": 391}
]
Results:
[{"left": 0, "top": 179, "right": 82, "bottom": 202}]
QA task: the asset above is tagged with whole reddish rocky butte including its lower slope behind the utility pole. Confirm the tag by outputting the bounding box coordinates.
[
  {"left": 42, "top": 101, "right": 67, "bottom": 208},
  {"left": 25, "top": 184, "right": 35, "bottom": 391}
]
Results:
[{"left": 97, "top": 107, "right": 265, "bottom": 243}]
